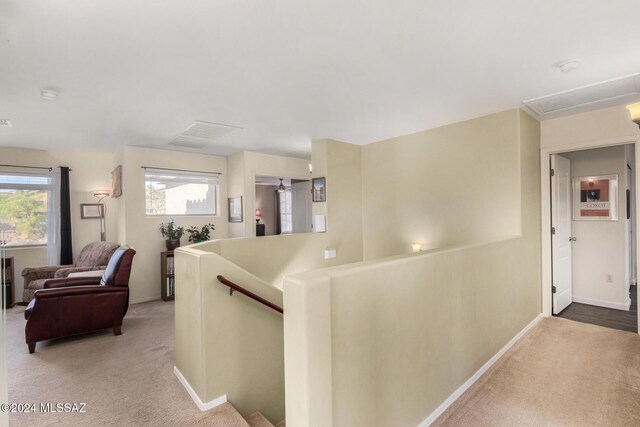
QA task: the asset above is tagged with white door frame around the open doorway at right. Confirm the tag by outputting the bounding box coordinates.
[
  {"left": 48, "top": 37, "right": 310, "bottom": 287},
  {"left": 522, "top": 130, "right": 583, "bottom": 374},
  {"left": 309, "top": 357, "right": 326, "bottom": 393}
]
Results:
[{"left": 540, "top": 136, "right": 640, "bottom": 334}]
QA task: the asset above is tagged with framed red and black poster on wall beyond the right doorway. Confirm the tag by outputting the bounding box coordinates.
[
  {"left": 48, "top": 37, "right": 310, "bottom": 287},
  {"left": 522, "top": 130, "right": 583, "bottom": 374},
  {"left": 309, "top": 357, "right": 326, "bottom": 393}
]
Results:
[{"left": 573, "top": 175, "right": 618, "bottom": 221}]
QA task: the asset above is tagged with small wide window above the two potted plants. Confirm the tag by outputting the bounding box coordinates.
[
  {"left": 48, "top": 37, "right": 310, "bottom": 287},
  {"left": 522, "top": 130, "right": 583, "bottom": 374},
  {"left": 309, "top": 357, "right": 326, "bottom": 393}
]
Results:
[{"left": 144, "top": 168, "right": 218, "bottom": 215}]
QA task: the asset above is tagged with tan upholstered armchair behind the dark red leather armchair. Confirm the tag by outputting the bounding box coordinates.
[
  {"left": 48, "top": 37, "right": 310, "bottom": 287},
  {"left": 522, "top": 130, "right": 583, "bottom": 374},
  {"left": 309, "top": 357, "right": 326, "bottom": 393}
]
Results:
[{"left": 22, "top": 242, "right": 120, "bottom": 303}]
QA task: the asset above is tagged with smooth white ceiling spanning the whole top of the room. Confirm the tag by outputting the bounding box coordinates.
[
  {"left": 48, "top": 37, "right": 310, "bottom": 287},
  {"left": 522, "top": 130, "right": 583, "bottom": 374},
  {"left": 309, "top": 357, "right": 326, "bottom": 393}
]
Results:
[{"left": 0, "top": 0, "right": 640, "bottom": 156}]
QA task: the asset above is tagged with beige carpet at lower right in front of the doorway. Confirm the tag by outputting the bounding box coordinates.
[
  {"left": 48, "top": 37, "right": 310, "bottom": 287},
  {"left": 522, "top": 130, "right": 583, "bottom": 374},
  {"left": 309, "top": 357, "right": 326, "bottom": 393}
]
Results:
[{"left": 433, "top": 318, "right": 640, "bottom": 426}]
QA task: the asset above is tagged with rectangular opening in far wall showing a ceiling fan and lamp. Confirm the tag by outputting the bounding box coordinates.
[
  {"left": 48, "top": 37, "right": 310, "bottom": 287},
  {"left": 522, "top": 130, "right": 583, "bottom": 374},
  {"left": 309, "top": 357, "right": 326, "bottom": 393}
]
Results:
[{"left": 255, "top": 176, "right": 313, "bottom": 236}]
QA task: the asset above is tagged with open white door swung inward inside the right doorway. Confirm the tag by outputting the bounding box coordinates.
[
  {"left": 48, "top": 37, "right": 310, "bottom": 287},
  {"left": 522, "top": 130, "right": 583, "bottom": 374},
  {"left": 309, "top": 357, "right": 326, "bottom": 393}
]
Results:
[{"left": 551, "top": 154, "right": 573, "bottom": 314}]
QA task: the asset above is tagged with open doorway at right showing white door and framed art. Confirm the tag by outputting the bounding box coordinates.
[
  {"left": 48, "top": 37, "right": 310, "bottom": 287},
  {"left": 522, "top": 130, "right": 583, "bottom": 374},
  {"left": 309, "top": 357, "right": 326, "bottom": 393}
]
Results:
[{"left": 550, "top": 144, "right": 638, "bottom": 332}]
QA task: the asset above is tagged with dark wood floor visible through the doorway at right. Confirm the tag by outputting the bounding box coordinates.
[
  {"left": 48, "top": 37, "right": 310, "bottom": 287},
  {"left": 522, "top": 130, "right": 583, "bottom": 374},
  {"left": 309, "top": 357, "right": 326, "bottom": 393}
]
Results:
[{"left": 558, "top": 286, "right": 638, "bottom": 332}]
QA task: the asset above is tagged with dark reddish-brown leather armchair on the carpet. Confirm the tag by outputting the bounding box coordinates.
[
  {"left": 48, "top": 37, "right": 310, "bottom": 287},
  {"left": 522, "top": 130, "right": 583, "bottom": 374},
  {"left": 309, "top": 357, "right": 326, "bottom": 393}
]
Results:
[{"left": 24, "top": 247, "right": 136, "bottom": 353}]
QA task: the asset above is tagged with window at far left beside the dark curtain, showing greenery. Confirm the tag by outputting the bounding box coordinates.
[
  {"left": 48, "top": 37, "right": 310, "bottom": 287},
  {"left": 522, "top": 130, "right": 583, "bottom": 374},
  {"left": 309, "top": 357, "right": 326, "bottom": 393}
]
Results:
[{"left": 0, "top": 171, "right": 52, "bottom": 247}]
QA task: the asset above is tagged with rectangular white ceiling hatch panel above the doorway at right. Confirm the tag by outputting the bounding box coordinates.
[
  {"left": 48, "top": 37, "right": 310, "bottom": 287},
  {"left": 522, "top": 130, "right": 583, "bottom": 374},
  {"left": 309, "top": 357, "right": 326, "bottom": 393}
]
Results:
[{"left": 523, "top": 74, "right": 640, "bottom": 120}]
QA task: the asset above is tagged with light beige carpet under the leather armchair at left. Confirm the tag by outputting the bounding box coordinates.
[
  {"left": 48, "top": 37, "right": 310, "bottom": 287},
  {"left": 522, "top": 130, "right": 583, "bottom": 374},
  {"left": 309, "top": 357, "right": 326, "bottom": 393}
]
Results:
[{"left": 7, "top": 301, "right": 248, "bottom": 427}]
